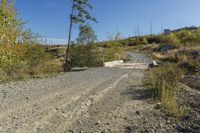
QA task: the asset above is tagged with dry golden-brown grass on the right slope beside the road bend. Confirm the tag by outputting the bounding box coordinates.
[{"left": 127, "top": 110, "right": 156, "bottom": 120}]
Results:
[{"left": 151, "top": 46, "right": 200, "bottom": 76}]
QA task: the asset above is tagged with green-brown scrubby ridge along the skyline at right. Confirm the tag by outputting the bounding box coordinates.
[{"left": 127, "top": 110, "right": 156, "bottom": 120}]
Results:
[{"left": 117, "top": 28, "right": 200, "bottom": 48}]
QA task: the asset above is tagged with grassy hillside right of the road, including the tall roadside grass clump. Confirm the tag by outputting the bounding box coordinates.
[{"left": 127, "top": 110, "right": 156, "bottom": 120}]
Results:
[{"left": 137, "top": 28, "right": 200, "bottom": 118}]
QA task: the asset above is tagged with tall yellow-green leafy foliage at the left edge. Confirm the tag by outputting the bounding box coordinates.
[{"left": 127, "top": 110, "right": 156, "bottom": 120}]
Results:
[{"left": 0, "top": 0, "right": 61, "bottom": 81}]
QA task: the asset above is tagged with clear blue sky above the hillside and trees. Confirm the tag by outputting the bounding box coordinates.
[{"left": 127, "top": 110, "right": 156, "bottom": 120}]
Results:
[{"left": 16, "top": 0, "right": 200, "bottom": 40}]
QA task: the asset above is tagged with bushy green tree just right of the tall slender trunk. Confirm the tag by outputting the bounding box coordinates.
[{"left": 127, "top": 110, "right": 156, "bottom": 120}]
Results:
[{"left": 69, "top": 25, "right": 103, "bottom": 68}]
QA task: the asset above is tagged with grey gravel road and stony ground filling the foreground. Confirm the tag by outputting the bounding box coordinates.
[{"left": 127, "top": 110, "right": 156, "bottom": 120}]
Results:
[{"left": 0, "top": 54, "right": 200, "bottom": 133}]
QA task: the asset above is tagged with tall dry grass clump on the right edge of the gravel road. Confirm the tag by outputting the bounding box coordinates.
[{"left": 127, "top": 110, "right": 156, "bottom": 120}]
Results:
[{"left": 144, "top": 65, "right": 185, "bottom": 118}]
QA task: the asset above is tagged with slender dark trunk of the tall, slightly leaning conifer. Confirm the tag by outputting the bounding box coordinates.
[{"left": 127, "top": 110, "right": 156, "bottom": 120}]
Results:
[{"left": 64, "top": 0, "right": 74, "bottom": 72}]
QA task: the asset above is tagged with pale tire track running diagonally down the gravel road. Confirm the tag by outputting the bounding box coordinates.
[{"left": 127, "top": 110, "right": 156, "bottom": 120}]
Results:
[{"left": 37, "top": 72, "right": 128, "bottom": 132}]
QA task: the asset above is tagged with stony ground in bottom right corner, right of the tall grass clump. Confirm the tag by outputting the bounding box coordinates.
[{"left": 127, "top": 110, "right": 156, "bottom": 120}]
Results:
[{"left": 177, "top": 84, "right": 200, "bottom": 133}]
